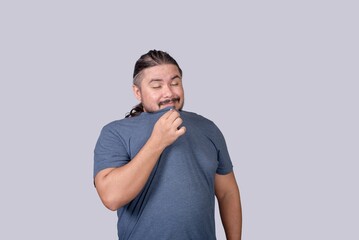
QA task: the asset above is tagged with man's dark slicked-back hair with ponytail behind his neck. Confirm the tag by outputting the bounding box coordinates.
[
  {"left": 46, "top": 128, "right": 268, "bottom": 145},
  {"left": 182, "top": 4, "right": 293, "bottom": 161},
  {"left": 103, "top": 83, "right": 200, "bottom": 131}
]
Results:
[{"left": 125, "top": 50, "right": 182, "bottom": 118}]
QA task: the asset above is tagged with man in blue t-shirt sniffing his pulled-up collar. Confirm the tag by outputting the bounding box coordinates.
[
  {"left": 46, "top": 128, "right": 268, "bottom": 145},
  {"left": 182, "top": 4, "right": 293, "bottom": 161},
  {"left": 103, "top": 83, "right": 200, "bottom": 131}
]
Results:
[{"left": 94, "top": 50, "right": 242, "bottom": 240}]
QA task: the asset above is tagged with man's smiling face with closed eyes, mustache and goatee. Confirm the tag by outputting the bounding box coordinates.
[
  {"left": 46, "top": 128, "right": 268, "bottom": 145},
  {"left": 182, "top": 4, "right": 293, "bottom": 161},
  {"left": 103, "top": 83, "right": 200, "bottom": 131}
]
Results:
[{"left": 133, "top": 64, "right": 184, "bottom": 112}]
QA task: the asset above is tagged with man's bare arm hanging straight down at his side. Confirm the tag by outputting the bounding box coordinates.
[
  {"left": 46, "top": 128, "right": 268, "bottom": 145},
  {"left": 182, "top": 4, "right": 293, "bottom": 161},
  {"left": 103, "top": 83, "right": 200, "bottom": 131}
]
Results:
[{"left": 215, "top": 172, "right": 242, "bottom": 240}]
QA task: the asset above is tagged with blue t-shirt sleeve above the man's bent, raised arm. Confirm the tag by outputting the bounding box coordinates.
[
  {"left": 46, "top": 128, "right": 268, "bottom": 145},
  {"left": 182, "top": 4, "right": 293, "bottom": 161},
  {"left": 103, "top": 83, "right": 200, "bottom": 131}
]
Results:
[{"left": 93, "top": 125, "right": 130, "bottom": 177}]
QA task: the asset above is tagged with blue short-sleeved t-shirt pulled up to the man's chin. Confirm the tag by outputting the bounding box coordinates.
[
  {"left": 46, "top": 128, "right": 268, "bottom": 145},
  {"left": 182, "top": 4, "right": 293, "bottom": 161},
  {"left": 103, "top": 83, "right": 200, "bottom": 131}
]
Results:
[{"left": 94, "top": 108, "right": 232, "bottom": 240}]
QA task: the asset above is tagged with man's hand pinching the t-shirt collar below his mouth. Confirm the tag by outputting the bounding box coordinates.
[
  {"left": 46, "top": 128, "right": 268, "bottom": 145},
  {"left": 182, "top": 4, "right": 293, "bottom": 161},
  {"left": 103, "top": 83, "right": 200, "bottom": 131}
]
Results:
[{"left": 150, "top": 109, "right": 186, "bottom": 149}]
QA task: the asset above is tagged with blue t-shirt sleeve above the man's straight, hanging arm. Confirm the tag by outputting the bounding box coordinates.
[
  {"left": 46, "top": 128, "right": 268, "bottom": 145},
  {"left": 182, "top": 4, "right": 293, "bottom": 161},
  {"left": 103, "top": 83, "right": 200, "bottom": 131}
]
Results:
[{"left": 214, "top": 126, "right": 233, "bottom": 175}]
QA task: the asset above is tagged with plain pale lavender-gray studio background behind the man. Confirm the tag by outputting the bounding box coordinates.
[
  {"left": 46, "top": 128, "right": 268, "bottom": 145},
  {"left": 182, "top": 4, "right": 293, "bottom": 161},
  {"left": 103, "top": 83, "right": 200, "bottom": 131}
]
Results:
[{"left": 0, "top": 0, "right": 359, "bottom": 240}]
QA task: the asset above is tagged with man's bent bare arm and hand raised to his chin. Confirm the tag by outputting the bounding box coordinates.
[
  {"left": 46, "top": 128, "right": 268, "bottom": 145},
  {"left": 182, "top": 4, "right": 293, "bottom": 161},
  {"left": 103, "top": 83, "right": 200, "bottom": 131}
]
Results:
[{"left": 95, "top": 110, "right": 186, "bottom": 211}]
